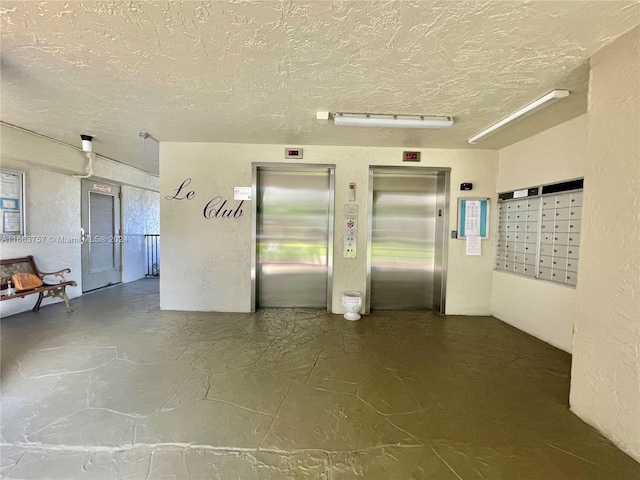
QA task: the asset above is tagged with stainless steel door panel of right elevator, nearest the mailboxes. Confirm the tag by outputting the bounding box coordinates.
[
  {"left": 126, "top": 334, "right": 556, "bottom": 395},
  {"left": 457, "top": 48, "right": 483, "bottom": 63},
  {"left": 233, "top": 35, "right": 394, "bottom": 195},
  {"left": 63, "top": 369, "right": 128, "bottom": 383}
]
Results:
[{"left": 370, "top": 170, "right": 438, "bottom": 310}]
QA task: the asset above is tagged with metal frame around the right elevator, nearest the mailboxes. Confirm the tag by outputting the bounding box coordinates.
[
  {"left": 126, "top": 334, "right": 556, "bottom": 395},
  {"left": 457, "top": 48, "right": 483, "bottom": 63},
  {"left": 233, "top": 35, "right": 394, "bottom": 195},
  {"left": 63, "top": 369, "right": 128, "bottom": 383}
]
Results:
[{"left": 365, "top": 165, "right": 451, "bottom": 315}]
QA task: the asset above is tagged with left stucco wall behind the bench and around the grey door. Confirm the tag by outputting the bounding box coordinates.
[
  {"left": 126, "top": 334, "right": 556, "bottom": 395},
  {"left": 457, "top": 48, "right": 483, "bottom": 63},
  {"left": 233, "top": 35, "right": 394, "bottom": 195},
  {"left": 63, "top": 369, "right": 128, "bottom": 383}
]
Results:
[{"left": 0, "top": 125, "right": 159, "bottom": 317}]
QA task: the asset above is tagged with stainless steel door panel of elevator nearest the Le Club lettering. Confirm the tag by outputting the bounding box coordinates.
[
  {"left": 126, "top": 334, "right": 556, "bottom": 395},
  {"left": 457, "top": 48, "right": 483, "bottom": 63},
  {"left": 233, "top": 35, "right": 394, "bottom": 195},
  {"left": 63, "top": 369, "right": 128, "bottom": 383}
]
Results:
[{"left": 256, "top": 168, "right": 332, "bottom": 308}]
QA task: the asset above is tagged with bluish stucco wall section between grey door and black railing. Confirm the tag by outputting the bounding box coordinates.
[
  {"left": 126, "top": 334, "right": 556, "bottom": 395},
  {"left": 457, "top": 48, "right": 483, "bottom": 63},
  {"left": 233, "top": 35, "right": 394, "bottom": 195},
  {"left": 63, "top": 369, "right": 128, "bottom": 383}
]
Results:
[{"left": 122, "top": 186, "right": 160, "bottom": 283}]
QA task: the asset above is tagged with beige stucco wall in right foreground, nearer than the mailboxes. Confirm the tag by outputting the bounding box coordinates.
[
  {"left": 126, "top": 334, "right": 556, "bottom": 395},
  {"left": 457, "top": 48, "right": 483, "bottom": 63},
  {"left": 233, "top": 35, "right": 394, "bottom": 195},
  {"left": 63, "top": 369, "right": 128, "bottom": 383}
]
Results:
[{"left": 570, "top": 27, "right": 640, "bottom": 461}]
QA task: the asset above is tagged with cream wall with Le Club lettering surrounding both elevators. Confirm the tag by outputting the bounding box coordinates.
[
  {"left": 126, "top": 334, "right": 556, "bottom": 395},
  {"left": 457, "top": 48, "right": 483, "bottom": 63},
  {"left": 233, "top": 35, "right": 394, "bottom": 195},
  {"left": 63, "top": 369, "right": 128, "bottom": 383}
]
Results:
[{"left": 160, "top": 142, "right": 497, "bottom": 315}]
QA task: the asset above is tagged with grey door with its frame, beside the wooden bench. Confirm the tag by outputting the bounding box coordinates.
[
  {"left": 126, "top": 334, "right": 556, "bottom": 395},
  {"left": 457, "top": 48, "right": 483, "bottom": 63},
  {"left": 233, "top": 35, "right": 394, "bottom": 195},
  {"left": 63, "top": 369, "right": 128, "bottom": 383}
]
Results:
[{"left": 81, "top": 179, "right": 122, "bottom": 292}]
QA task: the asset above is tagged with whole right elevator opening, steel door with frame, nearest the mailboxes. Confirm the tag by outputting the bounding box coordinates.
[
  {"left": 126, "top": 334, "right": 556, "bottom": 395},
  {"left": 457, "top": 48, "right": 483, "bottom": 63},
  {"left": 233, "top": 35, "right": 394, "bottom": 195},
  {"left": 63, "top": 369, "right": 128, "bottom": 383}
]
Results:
[{"left": 366, "top": 167, "right": 449, "bottom": 313}]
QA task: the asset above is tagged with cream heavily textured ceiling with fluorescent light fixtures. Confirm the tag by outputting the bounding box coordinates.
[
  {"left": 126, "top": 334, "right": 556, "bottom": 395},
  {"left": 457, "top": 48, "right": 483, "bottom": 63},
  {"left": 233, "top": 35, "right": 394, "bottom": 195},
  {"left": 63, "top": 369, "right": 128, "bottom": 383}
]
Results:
[{"left": 0, "top": 0, "right": 640, "bottom": 173}]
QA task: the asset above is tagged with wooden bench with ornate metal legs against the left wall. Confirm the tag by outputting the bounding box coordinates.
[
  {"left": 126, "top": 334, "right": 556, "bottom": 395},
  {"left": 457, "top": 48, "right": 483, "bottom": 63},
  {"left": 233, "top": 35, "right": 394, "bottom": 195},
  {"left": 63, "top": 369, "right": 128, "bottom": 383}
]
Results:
[{"left": 0, "top": 255, "right": 77, "bottom": 312}]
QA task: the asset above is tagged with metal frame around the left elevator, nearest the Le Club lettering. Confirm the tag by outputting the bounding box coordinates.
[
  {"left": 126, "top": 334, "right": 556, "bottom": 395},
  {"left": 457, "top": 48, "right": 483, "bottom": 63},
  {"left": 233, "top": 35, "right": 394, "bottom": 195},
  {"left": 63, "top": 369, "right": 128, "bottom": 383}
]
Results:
[{"left": 251, "top": 162, "right": 336, "bottom": 312}]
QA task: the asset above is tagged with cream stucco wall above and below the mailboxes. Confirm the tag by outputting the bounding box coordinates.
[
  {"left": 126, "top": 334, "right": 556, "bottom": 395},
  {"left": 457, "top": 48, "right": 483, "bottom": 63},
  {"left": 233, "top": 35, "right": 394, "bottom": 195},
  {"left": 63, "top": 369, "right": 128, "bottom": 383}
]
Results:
[{"left": 491, "top": 115, "right": 587, "bottom": 352}]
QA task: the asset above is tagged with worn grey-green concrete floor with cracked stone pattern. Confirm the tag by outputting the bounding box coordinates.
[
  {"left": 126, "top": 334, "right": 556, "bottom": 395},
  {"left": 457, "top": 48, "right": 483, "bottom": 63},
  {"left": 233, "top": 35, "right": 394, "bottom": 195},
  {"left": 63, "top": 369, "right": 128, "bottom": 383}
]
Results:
[{"left": 1, "top": 280, "right": 640, "bottom": 480}]
